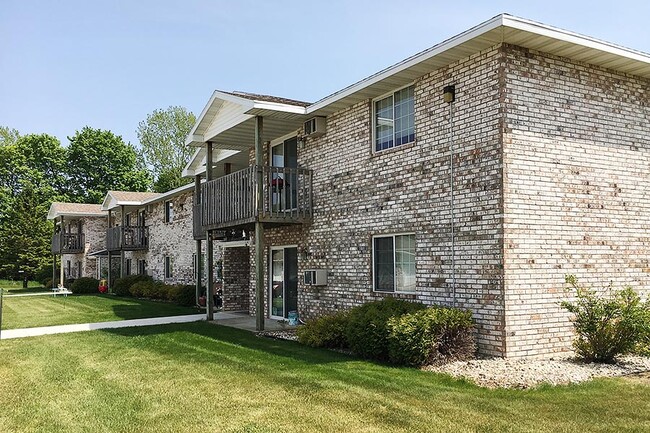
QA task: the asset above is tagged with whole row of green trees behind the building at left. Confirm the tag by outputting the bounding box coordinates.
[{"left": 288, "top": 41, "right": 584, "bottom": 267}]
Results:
[{"left": 0, "top": 107, "right": 195, "bottom": 279}]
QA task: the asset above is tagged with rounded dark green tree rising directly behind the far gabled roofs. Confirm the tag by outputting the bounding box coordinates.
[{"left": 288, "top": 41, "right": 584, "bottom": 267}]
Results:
[{"left": 68, "top": 126, "right": 151, "bottom": 203}]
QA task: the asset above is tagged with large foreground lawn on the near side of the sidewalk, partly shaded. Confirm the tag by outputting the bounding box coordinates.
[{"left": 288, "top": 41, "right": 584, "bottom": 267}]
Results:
[{"left": 0, "top": 322, "right": 650, "bottom": 433}]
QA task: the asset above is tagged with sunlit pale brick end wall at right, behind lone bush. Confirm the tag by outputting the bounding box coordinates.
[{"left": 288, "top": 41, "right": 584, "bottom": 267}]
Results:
[{"left": 503, "top": 46, "right": 650, "bottom": 357}]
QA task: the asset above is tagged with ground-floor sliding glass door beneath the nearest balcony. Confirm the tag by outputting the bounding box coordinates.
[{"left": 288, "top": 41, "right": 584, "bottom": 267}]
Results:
[{"left": 269, "top": 247, "right": 298, "bottom": 319}]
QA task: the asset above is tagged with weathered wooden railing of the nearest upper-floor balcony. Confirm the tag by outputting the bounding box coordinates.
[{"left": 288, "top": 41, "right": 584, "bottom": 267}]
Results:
[{"left": 195, "top": 166, "right": 312, "bottom": 230}]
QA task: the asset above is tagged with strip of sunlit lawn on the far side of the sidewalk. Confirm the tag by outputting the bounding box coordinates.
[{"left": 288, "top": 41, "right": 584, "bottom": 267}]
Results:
[{"left": 0, "top": 295, "right": 199, "bottom": 330}]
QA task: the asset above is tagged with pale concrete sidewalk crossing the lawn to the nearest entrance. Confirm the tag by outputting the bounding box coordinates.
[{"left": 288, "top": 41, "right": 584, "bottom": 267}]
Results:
[{"left": 0, "top": 314, "right": 205, "bottom": 340}]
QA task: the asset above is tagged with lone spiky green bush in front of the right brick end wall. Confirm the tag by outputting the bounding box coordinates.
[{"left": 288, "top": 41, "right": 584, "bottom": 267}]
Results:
[{"left": 561, "top": 275, "right": 648, "bottom": 363}]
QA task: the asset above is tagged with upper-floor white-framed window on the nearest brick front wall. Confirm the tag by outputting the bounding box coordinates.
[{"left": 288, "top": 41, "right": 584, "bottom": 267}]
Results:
[{"left": 373, "top": 86, "right": 415, "bottom": 152}]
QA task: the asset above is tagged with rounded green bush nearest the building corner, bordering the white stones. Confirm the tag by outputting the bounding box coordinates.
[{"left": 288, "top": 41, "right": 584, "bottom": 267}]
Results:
[{"left": 387, "top": 307, "right": 476, "bottom": 366}]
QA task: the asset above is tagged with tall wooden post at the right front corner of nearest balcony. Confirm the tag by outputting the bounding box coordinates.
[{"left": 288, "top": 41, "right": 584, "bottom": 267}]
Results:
[{"left": 255, "top": 116, "right": 266, "bottom": 331}]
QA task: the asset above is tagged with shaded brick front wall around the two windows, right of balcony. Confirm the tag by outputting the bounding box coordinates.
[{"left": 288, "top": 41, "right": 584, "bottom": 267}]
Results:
[{"left": 244, "top": 48, "right": 504, "bottom": 355}]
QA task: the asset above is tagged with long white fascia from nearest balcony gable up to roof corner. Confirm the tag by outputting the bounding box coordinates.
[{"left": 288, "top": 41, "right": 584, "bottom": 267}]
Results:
[{"left": 306, "top": 15, "right": 504, "bottom": 114}]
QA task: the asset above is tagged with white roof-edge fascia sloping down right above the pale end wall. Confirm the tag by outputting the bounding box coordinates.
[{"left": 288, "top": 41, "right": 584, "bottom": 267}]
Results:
[{"left": 503, "top": 15, "right": 650, "bottom": 63}]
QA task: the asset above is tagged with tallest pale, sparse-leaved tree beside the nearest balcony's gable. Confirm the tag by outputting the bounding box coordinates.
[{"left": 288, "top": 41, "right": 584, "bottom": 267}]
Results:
[{"left": 136, "top": 106, "right": 196, "bottom": 192}]
